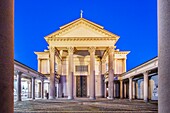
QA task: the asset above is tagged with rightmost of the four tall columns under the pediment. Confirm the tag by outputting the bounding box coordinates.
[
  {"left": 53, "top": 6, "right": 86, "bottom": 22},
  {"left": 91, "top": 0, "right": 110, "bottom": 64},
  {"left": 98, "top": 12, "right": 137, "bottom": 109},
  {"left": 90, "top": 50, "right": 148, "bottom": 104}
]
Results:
[{"left": 108, "top": 47, "right": 114, "bottom": 99}]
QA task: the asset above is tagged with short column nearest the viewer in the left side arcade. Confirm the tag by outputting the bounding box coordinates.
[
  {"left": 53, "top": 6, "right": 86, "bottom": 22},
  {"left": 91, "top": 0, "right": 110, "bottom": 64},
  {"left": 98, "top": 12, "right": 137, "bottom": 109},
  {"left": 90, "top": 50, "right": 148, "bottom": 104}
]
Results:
[{"left": 17, "top": 71, "right": 22, "bottom": 101}]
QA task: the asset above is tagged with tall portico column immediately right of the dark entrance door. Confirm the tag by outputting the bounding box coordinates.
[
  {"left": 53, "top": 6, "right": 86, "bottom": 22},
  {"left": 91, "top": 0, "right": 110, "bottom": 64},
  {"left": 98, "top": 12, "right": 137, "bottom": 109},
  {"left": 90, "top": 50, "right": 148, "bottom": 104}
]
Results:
[{"left": 89, "top": 47, "right": 96, "bottom": 100}]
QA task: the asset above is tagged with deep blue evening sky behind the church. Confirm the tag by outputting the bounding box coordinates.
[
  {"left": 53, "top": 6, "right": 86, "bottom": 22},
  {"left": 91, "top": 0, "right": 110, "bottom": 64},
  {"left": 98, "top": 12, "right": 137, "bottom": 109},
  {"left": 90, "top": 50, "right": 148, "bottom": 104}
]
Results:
[{"left": 14, "top": 0, "right": 158, "bottom": 70}]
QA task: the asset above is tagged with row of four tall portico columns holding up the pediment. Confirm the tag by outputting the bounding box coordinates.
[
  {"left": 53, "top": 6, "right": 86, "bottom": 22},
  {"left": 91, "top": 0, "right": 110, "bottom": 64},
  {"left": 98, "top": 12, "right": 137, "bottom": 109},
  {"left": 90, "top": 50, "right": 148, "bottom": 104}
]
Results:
[{"left": 50, "top": 46, "right": 114, "bottom": 100}]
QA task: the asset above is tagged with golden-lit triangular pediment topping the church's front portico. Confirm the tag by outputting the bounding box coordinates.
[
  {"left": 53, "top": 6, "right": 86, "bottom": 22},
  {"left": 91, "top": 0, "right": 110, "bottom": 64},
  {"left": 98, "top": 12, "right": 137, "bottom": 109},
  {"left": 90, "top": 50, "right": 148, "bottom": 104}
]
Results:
[{"left": 45, "top": 18, "right": 119, "bottom": 38}]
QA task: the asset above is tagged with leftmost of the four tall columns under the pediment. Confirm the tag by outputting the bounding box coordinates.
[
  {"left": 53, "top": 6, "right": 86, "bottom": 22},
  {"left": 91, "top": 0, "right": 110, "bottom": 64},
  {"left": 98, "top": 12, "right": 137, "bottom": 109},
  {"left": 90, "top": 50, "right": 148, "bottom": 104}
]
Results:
[{"left": 49, "top": 47, "right": 55, "bottom": 99}]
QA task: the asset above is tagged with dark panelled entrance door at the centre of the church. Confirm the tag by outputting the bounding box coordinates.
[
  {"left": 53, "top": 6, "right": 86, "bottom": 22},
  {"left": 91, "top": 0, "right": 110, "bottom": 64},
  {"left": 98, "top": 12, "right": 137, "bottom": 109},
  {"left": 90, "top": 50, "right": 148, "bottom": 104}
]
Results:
[{"left": 76, "top": 76, "right": 87, "bottom": 97}]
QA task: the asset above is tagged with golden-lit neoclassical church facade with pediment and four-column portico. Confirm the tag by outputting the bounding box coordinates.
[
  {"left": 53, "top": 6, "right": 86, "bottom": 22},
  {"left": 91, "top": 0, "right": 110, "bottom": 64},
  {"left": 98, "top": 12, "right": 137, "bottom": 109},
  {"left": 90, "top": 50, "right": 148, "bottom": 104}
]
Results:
[{"left": 35, "top": 17, "right": 129, "bottom": 99}]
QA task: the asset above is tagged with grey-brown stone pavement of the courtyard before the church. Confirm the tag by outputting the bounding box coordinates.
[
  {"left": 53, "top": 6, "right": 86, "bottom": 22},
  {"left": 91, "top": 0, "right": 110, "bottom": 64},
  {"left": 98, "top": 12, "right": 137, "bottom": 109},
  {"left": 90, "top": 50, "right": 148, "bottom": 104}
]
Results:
[{"left": 14, "top": 98, "right": 158, "bottom": 113}]
